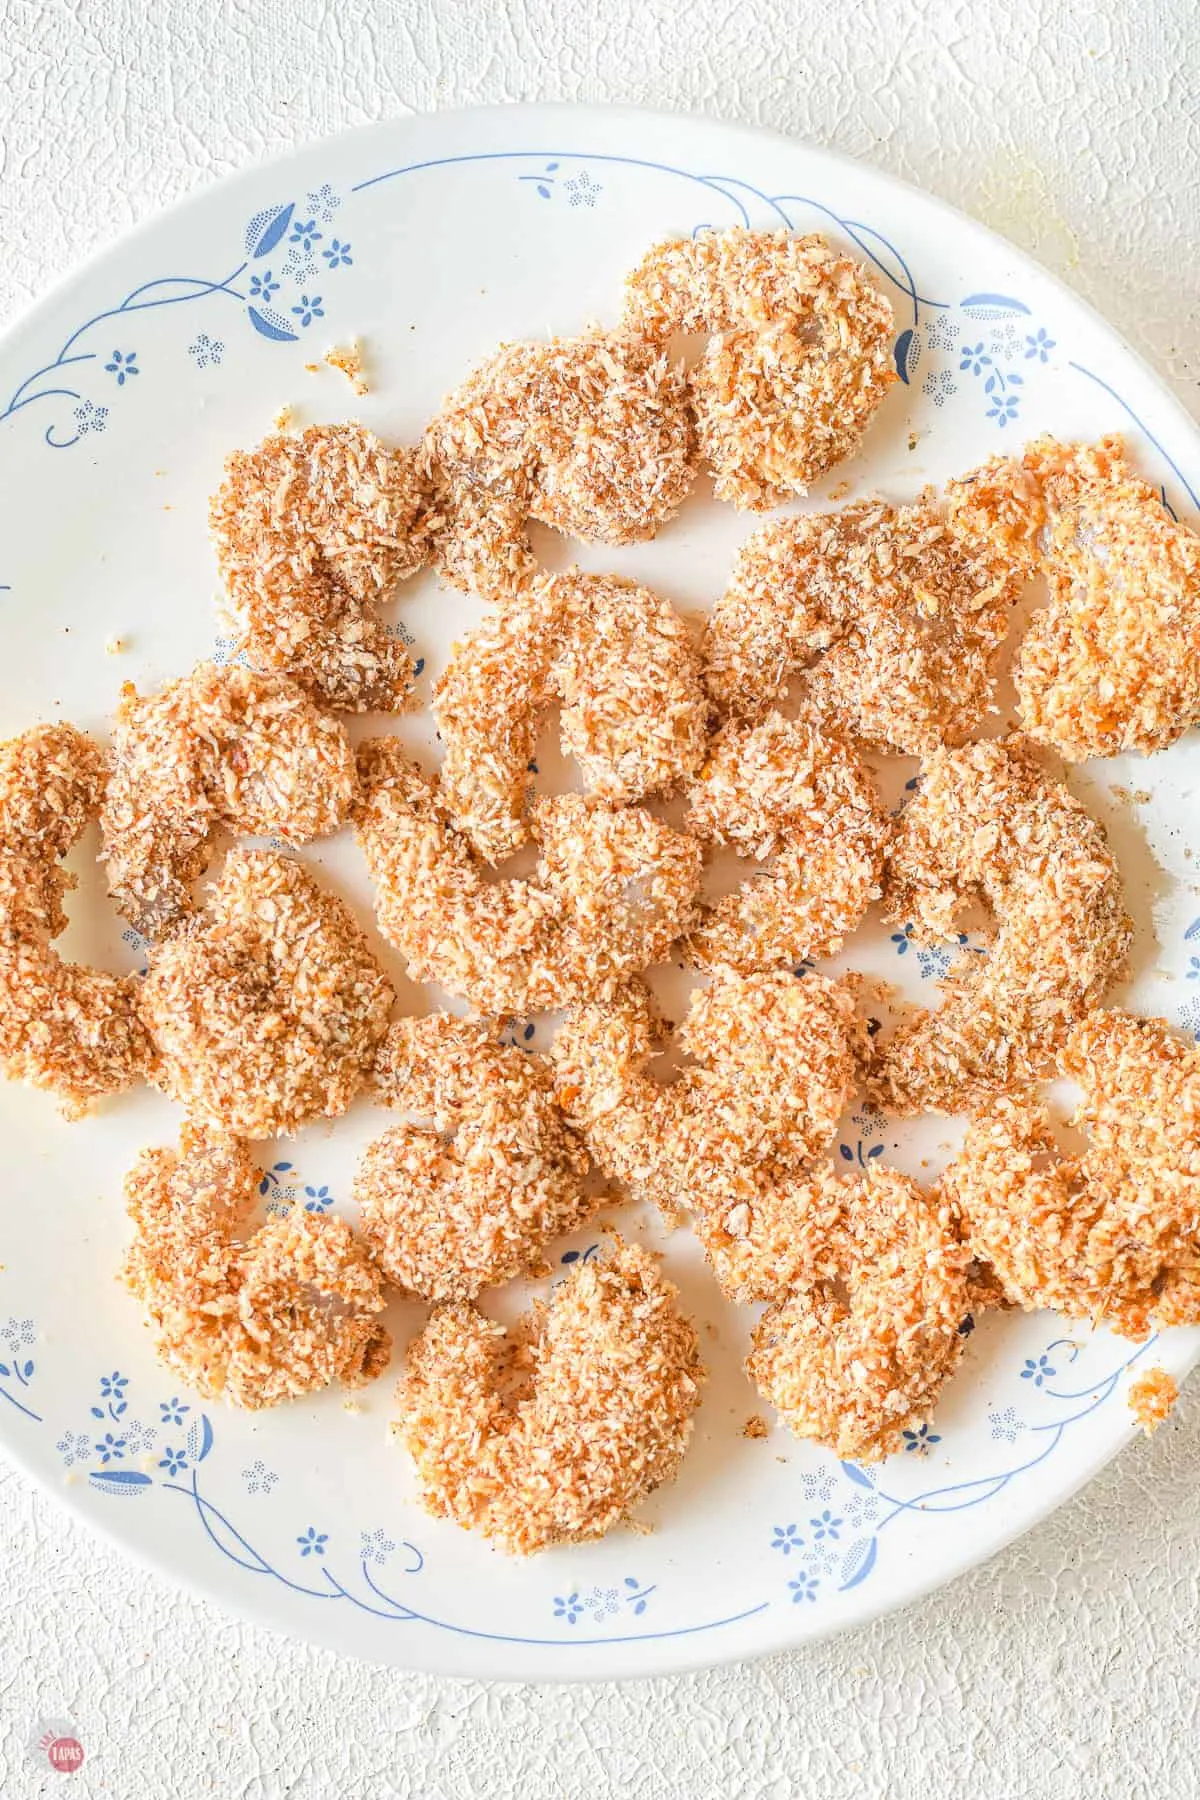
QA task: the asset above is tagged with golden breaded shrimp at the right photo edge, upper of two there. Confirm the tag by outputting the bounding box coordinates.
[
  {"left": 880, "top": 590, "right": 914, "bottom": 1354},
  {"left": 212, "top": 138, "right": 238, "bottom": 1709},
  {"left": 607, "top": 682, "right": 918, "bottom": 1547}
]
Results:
[{"left": 1015, "top": 437, "right": 1200, "bottom": 760}]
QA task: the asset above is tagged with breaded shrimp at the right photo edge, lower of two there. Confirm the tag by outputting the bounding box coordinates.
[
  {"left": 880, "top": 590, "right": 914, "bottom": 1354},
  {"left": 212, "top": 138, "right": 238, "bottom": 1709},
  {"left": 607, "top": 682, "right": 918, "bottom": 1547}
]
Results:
[{"left": 943, "top": 1012, "right": 1200, "bottom": 1337}]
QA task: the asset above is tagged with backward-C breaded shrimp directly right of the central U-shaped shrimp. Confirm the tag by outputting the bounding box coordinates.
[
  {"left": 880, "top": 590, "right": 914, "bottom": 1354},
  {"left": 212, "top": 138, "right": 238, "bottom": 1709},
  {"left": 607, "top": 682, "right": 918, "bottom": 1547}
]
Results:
[{"left": 687, "top": 713, "right": 891, "bottom": 972}]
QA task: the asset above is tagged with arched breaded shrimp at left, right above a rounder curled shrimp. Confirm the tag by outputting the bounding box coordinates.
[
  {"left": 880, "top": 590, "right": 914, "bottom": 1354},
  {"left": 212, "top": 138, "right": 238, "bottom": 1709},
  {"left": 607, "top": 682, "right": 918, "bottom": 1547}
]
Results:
[{"left": 101, "top": 662, "right": 358, "bottom": 938}]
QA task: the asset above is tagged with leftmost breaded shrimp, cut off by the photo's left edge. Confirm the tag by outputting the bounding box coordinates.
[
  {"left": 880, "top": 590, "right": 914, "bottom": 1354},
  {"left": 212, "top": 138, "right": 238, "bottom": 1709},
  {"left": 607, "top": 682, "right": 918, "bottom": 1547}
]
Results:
[{"left": 0, "top": 725, "right": 151, "bottom": 1116}]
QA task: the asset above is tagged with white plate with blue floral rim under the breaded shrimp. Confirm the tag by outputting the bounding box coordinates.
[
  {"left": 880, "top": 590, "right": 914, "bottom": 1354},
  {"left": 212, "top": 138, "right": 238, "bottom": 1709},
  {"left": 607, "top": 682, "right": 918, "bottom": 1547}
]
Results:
[{"left": 0, "top": 108, "right": 1200, "bottom": 1679}]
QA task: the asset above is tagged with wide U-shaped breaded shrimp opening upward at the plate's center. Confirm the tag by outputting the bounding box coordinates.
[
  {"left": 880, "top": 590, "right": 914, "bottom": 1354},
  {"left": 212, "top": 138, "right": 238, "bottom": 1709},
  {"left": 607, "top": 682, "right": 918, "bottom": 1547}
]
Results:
[{"left": 356, "top": 738, "right": 700, "bottom": 1013}]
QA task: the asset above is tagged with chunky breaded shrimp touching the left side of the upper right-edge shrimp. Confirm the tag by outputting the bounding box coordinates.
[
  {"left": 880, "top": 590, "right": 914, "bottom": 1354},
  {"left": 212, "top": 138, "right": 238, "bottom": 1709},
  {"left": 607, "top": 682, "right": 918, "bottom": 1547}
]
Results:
[{"left": 705, "top": 461, "right": 1040, "bottom": 756}]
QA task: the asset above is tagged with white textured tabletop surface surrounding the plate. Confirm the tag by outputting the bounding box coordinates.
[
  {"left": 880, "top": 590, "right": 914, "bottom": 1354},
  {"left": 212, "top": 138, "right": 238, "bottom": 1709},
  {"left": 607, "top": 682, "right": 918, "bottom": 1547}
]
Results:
[{"left": 0, "top": 0, "right": 1200, "bottom": 1800}]
